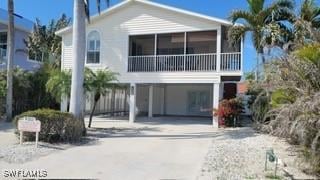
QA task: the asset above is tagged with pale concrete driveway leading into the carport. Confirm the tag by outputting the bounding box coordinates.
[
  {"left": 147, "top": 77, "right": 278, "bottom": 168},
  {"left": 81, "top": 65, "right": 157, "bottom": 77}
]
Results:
[{"left": 0, "top": 117, "right": 217, "bottom": 180}]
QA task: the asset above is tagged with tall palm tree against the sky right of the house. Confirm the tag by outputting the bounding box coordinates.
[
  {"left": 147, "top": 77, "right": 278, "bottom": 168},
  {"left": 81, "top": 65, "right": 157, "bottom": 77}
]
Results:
[{"left": 229, "top": 0, "right": 294, "bottom": 80}]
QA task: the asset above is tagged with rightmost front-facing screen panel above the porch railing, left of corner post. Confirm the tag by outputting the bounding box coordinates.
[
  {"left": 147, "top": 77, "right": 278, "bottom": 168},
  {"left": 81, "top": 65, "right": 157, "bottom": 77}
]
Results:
[{"left": 187, "top": 31, "right": 217, "bottom": 54}]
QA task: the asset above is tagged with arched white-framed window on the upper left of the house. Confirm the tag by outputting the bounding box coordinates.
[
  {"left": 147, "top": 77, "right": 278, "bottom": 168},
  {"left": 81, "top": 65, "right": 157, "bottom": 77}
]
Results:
[{"left": 87, "top": 31, "right": 100, "bottom": 64}]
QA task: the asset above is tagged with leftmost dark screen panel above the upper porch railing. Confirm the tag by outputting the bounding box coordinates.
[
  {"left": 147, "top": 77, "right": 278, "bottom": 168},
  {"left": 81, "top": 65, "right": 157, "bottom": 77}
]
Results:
[{"left": 129, "top": 35, "right": 155, "bottom": 56}]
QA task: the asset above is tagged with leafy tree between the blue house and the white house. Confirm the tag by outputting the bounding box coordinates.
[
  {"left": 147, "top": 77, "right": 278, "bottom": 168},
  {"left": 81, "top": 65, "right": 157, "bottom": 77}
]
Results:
[{"left": 25, "top": 14, "right": 70, "bottom": 67}]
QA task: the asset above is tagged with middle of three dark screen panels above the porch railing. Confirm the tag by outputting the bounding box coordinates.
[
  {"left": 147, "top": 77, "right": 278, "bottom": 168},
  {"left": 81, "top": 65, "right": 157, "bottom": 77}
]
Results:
[{"left": 157, "top": 33, "right": 184, "bottom": 55}]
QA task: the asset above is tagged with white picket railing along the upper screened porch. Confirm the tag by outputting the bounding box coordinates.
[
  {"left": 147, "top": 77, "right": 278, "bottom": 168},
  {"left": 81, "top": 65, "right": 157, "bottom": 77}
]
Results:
[{"left": 128, "top": 53, "right": 241, "bottom": 72}]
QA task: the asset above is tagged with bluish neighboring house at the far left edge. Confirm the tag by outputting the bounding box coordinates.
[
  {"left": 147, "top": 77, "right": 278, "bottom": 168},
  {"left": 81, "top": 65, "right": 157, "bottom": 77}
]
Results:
[{"left": 0, "top": 9, "right": 41, "bottom": 70}]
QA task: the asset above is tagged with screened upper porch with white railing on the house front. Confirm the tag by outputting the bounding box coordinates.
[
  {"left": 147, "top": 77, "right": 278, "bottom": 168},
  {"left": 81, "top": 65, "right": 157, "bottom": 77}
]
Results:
[{"left": 128, "top": 28, "right": 242, "bottom": 72}]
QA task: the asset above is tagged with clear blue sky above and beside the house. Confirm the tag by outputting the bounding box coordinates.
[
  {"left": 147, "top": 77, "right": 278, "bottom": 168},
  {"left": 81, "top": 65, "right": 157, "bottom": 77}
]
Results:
[{"left": 0, "top": 0, "right": 310, "bottom": 72}]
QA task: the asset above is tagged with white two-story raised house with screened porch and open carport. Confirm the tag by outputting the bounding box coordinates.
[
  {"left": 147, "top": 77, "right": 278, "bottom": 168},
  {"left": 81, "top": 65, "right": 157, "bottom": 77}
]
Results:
[{"left": 56, "top": 0, "right": 243, "bottom": 127}]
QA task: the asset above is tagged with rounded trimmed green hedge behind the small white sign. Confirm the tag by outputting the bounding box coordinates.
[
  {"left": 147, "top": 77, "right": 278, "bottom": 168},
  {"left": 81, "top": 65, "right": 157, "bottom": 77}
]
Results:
[{"left": 13, "top": 109, "right": 84, "bottom": 143}]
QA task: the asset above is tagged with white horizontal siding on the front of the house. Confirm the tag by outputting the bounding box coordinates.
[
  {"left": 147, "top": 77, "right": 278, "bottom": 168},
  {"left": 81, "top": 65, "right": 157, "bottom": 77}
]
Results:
[{"left": 63, "top": 3, "right": 235, "bottom": 83}]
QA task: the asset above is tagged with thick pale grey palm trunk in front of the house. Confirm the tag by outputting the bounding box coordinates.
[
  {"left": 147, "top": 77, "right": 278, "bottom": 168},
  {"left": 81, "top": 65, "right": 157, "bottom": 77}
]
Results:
[{"left": 70, "top": 0, "right": 86, "bottom": 121}]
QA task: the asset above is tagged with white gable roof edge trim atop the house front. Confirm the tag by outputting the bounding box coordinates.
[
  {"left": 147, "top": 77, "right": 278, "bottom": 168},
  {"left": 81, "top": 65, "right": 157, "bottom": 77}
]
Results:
[{"left": 56, "top": 0, "right": 232, "bottom": 35}]
